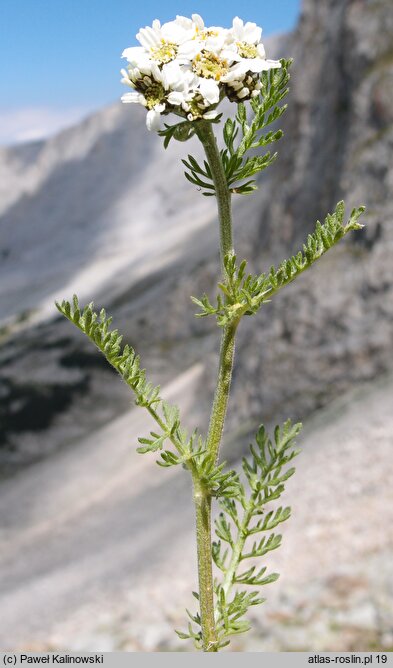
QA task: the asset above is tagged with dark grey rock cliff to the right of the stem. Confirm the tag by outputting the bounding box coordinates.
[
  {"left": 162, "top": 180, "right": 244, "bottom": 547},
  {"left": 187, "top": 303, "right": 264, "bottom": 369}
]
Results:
[{"left": 220, "top": 0, "right": 393, "bottom": 434}]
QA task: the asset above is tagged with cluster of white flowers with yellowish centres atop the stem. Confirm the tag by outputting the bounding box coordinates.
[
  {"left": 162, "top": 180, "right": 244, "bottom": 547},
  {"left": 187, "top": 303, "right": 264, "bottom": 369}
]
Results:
[{"left": 121, "top": 14, "right": 281, "bottom": 130}]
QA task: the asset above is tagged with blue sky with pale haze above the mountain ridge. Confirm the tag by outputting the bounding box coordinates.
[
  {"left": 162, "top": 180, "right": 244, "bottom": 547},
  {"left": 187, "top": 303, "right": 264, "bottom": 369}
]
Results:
[{"left": 0, "top": 0, "right": 300, "bottom": 143}]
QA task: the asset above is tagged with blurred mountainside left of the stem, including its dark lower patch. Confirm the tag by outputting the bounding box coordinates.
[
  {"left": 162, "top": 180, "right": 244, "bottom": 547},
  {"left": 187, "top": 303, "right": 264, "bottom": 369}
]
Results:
[{"left": 0, "top": 39, "right": 280, "bottom": 471}]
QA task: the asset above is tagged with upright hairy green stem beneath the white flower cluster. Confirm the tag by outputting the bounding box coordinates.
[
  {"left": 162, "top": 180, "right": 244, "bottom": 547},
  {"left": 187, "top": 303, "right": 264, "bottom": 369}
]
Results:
[{"left": 194, "top": 121, "right": 238, "bottom": 652}]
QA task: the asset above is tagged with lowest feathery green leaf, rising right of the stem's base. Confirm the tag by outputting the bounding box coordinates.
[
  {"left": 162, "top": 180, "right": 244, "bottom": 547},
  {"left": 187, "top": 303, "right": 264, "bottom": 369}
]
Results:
[{"left": 212, "top": 422, "right": 301, "bottom": 646}]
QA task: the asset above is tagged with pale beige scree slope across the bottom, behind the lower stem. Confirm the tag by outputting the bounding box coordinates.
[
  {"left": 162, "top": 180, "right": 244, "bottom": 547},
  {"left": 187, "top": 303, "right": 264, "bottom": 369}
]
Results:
[{"left": 0, "top": 366, "right": 393, "bottom": 651}]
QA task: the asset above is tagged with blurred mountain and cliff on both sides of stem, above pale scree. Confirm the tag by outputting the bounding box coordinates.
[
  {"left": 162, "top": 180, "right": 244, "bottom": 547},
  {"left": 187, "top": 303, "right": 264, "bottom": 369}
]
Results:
[{"left": 0, "top": 0, "right": 393, "bottom": 472}]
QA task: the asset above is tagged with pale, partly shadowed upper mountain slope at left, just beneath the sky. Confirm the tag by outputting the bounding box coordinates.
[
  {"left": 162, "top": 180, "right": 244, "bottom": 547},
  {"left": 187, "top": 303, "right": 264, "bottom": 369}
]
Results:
[{"left": 0, "top": 103, "right": 214, "bottom": 326}]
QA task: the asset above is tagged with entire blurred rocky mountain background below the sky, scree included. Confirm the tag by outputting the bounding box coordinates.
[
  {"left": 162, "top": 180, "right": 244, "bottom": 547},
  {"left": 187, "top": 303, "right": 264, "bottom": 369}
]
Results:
[{"left": 0, "top": 0, "right": 393, "bottom": 650}]
